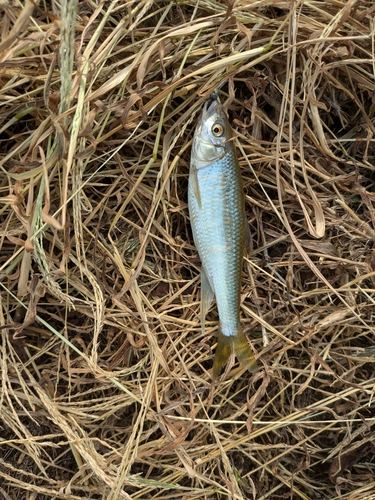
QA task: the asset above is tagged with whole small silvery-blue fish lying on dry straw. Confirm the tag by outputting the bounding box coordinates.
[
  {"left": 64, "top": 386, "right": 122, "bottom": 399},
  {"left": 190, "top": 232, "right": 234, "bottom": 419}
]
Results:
[{"left": 188, "top": 93, "right": 257, "bottom": 379}]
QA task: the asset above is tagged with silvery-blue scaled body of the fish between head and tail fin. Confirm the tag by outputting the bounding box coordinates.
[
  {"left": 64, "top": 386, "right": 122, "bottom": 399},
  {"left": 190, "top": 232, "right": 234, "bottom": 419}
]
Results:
[{"left": 189, "top": 152, "right": 244, "bottom": 334}]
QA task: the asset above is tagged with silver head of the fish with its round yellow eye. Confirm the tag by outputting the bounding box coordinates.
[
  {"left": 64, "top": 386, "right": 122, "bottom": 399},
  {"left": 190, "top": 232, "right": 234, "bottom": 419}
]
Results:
[{"left": 192, "top": 98, "right": 232, "bottom": 168}]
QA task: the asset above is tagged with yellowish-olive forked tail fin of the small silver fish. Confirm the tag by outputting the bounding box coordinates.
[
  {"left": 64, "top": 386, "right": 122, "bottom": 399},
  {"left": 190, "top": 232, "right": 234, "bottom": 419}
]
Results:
[{"left": 213, "top": 326, "right": 257, "bottom": 379}]
